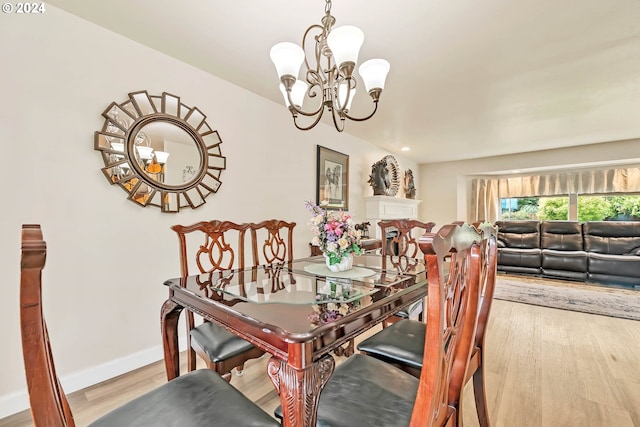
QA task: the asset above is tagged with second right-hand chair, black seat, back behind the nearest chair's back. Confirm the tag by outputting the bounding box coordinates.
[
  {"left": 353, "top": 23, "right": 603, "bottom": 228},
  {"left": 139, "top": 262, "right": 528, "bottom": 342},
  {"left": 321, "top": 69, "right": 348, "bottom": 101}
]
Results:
[{"left": 358, "top": 223, "right": 497, "bottom": 427}]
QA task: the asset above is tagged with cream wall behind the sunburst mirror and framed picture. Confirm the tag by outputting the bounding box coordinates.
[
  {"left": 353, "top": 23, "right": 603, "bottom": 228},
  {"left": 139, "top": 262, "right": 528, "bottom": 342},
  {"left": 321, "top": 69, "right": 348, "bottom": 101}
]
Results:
[{"left": 0, "top": 5, "right": 419, "bottom": 418}]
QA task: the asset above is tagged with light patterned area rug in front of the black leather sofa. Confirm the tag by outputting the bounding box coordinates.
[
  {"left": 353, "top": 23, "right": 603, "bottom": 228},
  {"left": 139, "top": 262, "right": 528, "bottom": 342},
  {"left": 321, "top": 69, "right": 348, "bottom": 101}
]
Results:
[{"left": 494, "top": 274, "right": 640, "bottom": 320}]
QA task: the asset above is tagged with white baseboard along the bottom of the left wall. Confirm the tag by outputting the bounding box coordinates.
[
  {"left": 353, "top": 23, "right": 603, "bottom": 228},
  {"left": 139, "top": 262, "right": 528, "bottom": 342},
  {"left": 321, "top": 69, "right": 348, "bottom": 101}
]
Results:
[{"left": 0, "top": 337, "right": 186, "bottom": 419}]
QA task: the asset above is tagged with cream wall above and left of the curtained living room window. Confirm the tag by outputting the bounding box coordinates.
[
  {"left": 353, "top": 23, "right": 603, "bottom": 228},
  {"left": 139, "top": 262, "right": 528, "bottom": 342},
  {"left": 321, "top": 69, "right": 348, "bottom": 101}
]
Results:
[{"left": 416, "top": 139, "right": 640, "bottom": 229}]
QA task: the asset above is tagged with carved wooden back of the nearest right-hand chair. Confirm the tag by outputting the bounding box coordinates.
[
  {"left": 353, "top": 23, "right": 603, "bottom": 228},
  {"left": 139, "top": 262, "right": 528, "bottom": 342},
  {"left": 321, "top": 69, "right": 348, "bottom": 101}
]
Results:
[{"left": 410, "top": 224, "right": 481, "bottom": 426}]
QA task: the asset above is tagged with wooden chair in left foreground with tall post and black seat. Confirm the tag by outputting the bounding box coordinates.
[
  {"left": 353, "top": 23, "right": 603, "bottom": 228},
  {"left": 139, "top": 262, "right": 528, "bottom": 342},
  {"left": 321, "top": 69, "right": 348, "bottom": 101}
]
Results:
[{"left": 20, "top": 224, "right": 280, "bottom": 427}]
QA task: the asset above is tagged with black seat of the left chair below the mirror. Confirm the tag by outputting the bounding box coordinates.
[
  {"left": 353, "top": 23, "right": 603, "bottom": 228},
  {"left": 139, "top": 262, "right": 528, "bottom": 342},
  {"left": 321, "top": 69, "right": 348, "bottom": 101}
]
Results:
[{"left": 190, "top": 322, "right": 254, "bottom": 362}]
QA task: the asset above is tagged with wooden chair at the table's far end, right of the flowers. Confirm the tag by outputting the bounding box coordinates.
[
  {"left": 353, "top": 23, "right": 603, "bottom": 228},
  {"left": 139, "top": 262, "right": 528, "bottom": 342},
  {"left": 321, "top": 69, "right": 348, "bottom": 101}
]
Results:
[{"left": 378, "top": 219, "right": 436, "bottom": 328}]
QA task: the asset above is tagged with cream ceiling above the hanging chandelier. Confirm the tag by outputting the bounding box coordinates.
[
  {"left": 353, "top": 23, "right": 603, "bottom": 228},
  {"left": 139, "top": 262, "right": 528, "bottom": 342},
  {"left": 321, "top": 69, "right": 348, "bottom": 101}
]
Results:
[{"left": 48, "top": 0, "right": 640, "bottom": 163}]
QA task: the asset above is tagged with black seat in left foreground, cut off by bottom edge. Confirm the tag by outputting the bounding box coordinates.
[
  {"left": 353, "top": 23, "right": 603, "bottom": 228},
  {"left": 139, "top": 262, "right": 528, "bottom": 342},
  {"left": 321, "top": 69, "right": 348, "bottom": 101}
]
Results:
[{"left": 90, "top": 369, "right": 280, "bottom": 427}]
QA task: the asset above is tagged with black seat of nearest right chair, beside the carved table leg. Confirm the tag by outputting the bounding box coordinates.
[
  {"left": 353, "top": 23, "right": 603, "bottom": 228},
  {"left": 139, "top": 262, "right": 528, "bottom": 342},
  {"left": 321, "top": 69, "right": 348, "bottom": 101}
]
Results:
[{"left": 276, "top": 354, "right": 424, "bottom": 427}]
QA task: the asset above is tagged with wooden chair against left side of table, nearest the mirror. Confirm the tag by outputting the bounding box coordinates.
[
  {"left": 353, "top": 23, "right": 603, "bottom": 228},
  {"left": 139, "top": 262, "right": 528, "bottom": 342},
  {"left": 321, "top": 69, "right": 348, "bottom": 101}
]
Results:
[{"left": 171, "top": 220, "right": 264, "bottom": 381}]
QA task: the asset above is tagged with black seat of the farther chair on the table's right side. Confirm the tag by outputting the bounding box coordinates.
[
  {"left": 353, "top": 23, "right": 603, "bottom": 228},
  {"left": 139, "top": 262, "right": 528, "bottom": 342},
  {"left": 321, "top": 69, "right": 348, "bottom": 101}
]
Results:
[{"left": 358, "top": 319, "right": 427, "bottom": 370}]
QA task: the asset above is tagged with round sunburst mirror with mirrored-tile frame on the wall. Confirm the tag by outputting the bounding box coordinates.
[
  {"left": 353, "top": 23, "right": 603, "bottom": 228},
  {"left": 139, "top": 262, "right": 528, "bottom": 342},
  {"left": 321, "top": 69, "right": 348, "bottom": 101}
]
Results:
[{"left": 94, "top": 91, "right": 227, "bottom": 212}]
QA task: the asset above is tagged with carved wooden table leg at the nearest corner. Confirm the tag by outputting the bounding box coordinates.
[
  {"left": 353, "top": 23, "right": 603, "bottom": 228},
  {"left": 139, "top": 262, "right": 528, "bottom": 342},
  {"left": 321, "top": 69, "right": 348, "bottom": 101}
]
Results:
[{"left": 267, "top": 355, "right": 335, "bottom": 427}]
